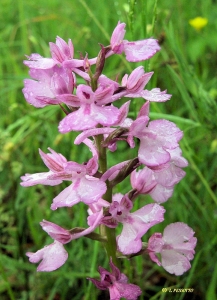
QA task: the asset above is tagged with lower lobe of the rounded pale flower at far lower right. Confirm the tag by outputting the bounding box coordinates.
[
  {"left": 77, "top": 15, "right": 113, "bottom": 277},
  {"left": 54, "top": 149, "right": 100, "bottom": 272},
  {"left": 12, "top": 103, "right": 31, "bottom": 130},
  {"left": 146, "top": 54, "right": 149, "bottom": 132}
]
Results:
[{"left": 161, "top": 250, "right": 191, "bottom": 276}]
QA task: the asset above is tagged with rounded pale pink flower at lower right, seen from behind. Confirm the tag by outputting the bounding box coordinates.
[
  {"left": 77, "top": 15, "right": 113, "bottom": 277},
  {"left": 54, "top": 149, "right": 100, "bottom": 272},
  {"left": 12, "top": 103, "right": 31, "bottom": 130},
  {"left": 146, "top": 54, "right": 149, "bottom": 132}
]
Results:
[{"left": 148, "top": 222, "right": 197, "bottom": 276}]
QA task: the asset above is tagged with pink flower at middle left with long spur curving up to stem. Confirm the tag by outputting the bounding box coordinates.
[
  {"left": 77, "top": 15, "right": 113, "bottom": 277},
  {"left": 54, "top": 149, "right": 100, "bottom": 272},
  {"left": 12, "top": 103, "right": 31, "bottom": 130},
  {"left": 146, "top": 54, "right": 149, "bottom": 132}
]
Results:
[{"left": 21, "top": 146, "right": 106, "bottom": 210}]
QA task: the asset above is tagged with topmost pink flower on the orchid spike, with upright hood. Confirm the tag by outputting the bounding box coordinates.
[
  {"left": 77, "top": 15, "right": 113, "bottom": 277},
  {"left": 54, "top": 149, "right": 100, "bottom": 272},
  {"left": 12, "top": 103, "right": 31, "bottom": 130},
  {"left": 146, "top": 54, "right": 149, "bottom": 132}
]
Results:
[{"left": 110, "top": 22, "right": 160, "bottom": 62}]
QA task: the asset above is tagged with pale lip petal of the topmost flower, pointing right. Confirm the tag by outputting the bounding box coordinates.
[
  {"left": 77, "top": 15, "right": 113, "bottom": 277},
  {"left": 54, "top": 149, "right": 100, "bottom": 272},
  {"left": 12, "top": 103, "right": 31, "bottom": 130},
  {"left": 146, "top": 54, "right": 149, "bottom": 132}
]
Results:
[{"left": 123, "top": 39, "right": 160, "bottom": 62}]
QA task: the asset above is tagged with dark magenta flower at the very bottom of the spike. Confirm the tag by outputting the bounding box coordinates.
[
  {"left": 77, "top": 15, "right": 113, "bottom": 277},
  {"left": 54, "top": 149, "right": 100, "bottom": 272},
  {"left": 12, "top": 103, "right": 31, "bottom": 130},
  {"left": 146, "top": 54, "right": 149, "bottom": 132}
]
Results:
[{"left": 87, "top": 259, "right": 142, "bottom": 300}]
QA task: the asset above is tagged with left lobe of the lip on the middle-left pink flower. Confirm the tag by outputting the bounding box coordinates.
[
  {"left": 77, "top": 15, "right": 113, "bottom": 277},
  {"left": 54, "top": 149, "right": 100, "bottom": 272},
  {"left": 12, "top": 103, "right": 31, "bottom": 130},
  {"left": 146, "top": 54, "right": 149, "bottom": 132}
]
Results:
[{"left": 51, "top": 184, "right": 80, "bottom": 210}]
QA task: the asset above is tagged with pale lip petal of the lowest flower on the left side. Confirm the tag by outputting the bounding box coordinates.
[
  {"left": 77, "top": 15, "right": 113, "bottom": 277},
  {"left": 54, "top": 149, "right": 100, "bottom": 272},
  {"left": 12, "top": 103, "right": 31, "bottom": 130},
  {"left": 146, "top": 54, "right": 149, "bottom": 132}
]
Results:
[{"left": 26, "top": 241, "right": 68, "bottom": 272}]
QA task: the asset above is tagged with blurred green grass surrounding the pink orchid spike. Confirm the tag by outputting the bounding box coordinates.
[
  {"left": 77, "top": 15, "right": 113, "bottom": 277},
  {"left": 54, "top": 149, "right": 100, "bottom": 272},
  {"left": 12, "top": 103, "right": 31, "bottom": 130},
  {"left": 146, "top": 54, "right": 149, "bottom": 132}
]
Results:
[{"left": 0, "top": 0, "right": 217, "bottom": 300}]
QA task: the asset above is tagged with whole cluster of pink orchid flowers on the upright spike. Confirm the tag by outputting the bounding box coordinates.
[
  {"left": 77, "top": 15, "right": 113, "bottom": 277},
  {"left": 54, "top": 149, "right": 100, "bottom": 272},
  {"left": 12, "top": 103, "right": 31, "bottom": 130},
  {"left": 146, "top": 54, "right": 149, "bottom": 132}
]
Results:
[{"left": 21, "top": 22, "right": 196, "bottom": 300}]
